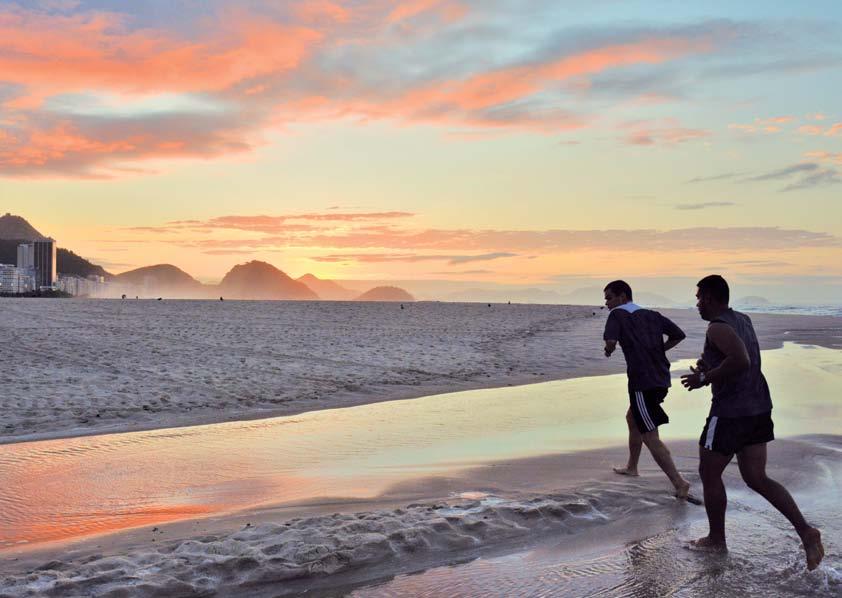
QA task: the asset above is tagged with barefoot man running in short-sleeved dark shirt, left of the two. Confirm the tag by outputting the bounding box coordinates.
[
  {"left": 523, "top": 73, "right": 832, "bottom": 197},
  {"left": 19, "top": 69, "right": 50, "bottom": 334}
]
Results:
[{"left": 603, "top": 280, "right": 690, "bottom": 499}]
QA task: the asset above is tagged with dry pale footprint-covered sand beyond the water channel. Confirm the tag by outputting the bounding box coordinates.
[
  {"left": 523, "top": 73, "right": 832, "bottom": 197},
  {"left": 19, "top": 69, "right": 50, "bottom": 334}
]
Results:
[{"left": 0, "top": 299, "right": 842, "bottom": 443}]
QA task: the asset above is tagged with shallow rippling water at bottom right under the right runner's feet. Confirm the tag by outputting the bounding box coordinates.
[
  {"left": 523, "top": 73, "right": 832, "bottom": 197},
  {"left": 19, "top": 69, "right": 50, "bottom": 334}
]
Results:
[{"left": 350, "top": 450, "right": 842, "bottom": 598}]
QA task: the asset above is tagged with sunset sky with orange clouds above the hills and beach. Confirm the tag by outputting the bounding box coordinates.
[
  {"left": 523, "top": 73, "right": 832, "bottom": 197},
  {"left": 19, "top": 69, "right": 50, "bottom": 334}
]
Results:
[{"left": 0, "top": 0, "right": 842, "bottom": 297}]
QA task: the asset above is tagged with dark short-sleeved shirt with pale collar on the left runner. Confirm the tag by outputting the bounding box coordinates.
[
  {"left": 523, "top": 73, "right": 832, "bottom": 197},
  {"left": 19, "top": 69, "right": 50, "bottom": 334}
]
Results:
[{"left": 602, "top": 303, "right": 686, "bottom": 390}]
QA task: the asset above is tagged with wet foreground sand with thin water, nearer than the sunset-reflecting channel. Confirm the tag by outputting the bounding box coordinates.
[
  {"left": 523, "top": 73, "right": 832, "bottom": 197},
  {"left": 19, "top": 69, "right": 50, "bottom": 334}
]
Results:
[{"left": 0, "top": 436, "right": 842, "bottom": 597}]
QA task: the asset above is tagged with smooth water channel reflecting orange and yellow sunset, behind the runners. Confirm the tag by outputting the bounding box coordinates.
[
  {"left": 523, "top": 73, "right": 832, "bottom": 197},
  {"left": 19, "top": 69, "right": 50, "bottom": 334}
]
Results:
[{"left": 0, "top": 344, "right": 842, "bottom": 550}]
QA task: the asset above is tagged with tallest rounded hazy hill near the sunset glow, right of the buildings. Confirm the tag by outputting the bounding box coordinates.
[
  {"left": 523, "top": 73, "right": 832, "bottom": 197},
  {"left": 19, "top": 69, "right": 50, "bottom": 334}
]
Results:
[{"left": 219, "top": 261, "right": 319, "bottom": 300}]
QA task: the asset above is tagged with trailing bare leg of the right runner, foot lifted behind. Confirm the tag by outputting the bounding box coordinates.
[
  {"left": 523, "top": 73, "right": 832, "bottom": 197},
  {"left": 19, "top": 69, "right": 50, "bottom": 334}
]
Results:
[{"left": 737, "top": 442, "right": 824, "bottom": 571}]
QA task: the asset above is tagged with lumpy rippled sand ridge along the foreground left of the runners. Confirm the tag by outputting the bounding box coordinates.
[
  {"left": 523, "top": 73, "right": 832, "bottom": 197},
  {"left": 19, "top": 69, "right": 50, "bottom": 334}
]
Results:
[{"left": 0, "top": 484, "right": 676, "bottom": 598}]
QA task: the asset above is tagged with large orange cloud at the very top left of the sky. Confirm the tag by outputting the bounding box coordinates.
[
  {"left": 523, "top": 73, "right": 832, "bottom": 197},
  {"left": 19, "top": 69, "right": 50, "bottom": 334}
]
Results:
[{"left": 0, "top": 10, "right": 322, "bottom": 99}]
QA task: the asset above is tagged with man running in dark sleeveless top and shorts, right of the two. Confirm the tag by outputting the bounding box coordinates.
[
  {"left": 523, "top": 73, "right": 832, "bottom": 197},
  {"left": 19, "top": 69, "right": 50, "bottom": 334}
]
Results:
[{"left": 681, "top": 274, "right": 824, "bottom": 571}]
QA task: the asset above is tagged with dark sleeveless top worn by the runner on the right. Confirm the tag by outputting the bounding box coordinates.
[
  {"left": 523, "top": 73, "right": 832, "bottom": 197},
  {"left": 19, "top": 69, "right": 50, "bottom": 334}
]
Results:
[{"left": 702, "top": 309, "right": 772, "bottom": 417}]
